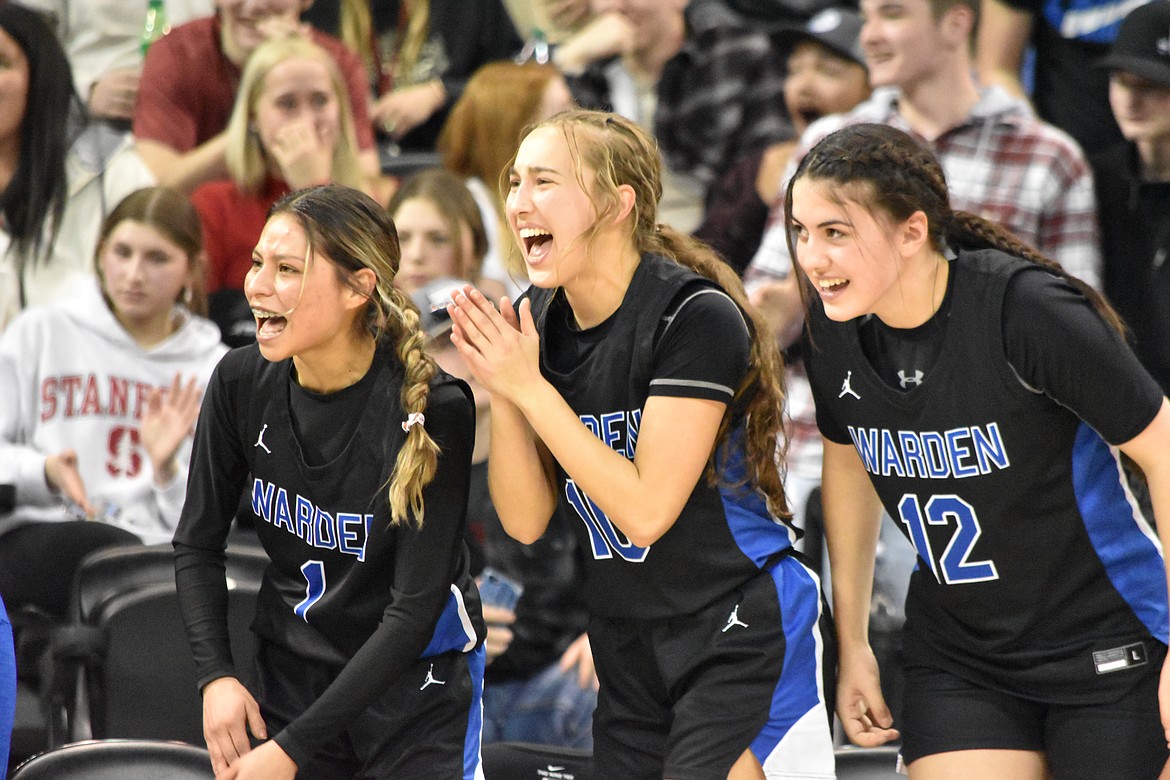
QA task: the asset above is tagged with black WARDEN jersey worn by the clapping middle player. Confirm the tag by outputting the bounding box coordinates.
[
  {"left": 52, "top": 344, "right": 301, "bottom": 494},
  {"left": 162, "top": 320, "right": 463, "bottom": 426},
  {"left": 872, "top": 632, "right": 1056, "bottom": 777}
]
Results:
[{"left": 527, "top": 255, "right": 793, "bottom": 619}]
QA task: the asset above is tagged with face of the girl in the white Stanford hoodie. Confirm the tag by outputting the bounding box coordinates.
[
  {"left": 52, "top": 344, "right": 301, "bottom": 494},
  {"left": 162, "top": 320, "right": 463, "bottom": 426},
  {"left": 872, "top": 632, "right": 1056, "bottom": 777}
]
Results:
[{"left": 98, "top": 220, "right": 193, "bottom": 333}]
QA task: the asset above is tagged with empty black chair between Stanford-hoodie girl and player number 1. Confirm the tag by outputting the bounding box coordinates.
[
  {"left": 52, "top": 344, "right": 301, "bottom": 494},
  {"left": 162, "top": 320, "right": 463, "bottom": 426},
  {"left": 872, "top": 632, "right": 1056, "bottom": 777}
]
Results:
[{"left": 42, "top": 545, "right": 268, "bottom": 747}]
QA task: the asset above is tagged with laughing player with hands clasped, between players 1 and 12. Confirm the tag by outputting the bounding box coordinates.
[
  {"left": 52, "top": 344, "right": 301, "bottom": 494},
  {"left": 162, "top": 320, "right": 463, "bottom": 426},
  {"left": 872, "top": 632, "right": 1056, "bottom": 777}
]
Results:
[{"left": 448, "top": 111, "right": 833, "bottom": 780}]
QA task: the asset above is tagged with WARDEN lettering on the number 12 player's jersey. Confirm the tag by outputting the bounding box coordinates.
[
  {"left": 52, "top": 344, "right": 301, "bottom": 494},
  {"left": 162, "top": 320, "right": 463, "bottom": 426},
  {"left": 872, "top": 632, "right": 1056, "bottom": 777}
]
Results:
[{"left": 848, "top": 422, "right": 1011, "bottom": 479}]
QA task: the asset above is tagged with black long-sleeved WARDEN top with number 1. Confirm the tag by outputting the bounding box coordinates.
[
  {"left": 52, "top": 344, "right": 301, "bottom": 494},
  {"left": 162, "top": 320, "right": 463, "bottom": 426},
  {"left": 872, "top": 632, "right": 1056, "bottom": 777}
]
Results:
[{"left": 176, "top": 345, "right": 484, "bottom": 684}]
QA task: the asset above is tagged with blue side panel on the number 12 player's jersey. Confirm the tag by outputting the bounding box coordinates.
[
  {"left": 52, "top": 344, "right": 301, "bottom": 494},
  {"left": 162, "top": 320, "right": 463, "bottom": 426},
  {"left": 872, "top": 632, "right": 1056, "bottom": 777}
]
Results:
[{"left": 1073, "top": 422, "right": 1168, "bottom": 643}]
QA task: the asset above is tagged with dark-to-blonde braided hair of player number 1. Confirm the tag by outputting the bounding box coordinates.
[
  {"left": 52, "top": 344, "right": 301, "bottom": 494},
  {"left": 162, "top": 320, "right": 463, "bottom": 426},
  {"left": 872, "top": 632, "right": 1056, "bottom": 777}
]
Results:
[{"left": 269, "top": 185, "right": 439, "bottom": 527}]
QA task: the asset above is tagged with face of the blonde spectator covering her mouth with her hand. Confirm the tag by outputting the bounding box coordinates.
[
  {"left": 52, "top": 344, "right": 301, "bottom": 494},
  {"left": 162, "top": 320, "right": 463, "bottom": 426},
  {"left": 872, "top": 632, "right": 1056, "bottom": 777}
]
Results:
[{"left": 253, "top": 57, "right": 340, "bottom": 155}]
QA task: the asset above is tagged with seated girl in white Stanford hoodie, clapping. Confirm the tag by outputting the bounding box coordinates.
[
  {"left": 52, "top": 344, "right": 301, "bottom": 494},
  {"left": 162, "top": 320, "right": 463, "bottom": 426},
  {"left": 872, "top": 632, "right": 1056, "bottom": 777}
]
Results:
[{"left": 0, "top": 187, "right": 226, "bottom": 617}]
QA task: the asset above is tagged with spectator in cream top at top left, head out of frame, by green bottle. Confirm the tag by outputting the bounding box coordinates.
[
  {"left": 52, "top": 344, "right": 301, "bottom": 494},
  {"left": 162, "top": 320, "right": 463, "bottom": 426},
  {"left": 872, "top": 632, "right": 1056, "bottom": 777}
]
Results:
[{"left": 23, "top": 0, "right": 215, "bottom": 130}]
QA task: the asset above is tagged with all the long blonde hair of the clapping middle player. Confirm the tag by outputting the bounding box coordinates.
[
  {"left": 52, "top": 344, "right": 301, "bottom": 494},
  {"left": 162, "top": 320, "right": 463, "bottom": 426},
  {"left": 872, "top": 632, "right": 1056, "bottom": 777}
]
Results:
[{"left": 509, "top": 110, "right": 792, "bottom": 522}]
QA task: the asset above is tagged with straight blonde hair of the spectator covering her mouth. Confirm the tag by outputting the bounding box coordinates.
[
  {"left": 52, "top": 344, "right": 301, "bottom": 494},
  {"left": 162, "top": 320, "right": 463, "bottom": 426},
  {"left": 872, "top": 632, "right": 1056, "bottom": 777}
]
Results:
[{"left": 223, "top": 35, "right": 362, "bottom": 193}]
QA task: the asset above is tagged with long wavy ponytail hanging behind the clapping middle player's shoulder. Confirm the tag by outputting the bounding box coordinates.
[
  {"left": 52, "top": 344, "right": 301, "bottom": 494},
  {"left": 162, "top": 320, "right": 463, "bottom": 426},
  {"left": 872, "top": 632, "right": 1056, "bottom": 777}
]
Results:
[{"left": 646, "top": 225, "right": 792, "bottom": 522}]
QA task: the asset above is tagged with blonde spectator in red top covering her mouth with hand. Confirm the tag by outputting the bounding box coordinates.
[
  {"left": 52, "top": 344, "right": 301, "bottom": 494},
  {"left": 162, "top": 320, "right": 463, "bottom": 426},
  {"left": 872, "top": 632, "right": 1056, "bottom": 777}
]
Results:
[{"left": 191, "top": 36, "right": 363, "bottom": 297}]
